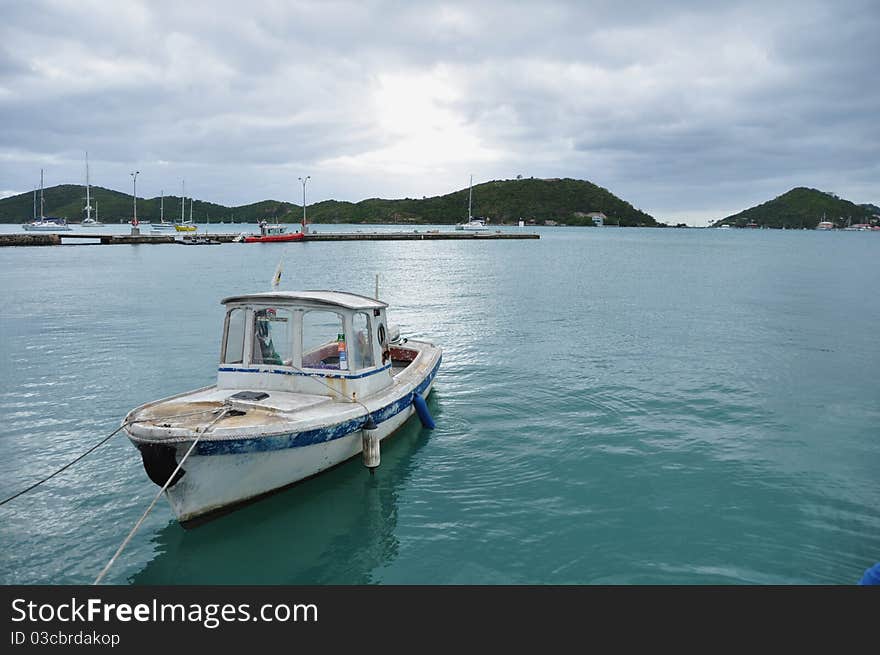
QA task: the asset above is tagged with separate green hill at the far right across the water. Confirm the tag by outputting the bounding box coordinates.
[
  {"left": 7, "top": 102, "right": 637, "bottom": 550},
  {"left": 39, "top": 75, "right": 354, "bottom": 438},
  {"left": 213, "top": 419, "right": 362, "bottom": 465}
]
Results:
[{"left": 713, "top": 187, "right": 875, "bottom": 229}]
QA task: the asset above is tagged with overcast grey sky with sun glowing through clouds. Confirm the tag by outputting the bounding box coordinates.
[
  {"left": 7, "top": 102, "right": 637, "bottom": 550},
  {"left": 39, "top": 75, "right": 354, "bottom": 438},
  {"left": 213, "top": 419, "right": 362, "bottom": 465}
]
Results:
[{"left": 0, "top": 0, "right": 880, "bottom": 225}]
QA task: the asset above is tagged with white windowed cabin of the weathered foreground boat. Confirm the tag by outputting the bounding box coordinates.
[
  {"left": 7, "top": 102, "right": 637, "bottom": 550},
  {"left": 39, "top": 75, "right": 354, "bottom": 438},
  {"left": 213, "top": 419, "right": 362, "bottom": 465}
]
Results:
[{"left": 217, "top": 291, "right": 393, "bottom": 400}]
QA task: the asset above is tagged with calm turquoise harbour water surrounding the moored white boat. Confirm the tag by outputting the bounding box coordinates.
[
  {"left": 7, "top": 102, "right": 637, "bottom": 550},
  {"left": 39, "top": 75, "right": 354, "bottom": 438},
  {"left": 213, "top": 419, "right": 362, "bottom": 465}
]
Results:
[{"left": 0, "top": 226, "right": 880, "bottom": 585}]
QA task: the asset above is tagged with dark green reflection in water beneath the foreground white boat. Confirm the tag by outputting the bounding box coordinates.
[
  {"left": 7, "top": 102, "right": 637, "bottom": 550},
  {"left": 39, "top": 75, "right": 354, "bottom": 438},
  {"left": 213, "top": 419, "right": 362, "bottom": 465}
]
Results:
[{"left": 129, "top": 412, "right": 441, "bottom": 585}]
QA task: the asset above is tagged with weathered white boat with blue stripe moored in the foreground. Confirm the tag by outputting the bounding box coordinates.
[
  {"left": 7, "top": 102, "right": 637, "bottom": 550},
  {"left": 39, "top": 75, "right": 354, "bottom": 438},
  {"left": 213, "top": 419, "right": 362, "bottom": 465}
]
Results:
[{"left": 123, "top": 290, "right": 442, "bottom": 525}]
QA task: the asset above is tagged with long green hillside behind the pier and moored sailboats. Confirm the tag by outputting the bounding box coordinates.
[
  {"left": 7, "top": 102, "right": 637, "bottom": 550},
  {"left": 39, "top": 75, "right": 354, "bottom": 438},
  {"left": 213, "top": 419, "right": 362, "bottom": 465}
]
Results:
[{"left": 0, "top": 178, "right": 657, "bottom": 226}]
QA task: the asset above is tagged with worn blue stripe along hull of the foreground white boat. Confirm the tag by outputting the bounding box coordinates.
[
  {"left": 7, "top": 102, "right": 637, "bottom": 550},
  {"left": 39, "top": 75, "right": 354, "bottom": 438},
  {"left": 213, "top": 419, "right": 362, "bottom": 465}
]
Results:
[{"left": 196, "top": 355, "right": 443, "bottom": 455}]
